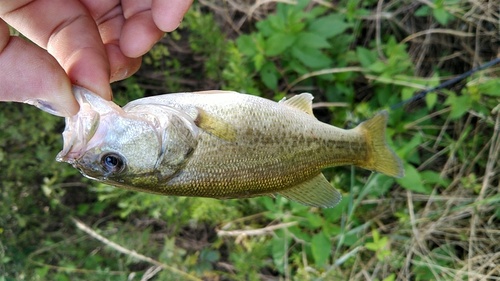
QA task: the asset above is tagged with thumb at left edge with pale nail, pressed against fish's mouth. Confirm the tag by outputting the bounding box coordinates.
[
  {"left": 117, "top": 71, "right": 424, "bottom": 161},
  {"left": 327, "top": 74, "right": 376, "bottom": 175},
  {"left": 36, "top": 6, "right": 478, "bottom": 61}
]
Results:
[{"left": 0, "top": 20, "right": 78, "bottom": 116}]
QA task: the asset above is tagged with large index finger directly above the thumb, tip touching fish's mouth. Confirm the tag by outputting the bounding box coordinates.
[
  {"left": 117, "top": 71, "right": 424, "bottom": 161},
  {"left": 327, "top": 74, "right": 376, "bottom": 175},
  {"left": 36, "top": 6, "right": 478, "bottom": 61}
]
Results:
[{"left": 0, "top": 0, "right": 111, "bottom": 100}]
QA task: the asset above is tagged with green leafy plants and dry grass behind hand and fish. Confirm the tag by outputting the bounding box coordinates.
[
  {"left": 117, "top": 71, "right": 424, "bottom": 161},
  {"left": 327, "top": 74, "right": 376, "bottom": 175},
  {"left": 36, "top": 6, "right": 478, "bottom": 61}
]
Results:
[{"left": 0, "top": 0, "right": 500, "bottom": 281}]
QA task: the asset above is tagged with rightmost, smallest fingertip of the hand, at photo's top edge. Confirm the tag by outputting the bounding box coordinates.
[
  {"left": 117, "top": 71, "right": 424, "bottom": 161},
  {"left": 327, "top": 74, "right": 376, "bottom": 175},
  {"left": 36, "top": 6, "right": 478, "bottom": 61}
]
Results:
[{"left": 151, "top": 0, "right": 193, "bottom": 32}]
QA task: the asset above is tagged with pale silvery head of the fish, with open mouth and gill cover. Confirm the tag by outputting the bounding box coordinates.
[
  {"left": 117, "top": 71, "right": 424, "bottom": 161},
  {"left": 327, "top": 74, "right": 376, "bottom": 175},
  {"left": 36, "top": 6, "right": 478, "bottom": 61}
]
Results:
[{"left": 57, "top": 86, "right": 198, "bottom": 185}]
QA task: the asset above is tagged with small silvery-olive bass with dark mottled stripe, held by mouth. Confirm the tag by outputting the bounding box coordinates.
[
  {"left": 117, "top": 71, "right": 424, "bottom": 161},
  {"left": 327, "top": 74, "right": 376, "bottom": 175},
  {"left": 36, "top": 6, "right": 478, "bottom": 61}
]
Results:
[{"left": 56, "top": 86, "right": 404, "bottom": 208}]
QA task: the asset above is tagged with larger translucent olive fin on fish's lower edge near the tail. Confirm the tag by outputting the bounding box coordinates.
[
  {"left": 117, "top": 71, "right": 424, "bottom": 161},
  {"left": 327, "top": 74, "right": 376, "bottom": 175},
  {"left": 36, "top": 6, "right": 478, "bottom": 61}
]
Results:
[{"left": 278, "top": 174, "right": 342, "bottom": 208}]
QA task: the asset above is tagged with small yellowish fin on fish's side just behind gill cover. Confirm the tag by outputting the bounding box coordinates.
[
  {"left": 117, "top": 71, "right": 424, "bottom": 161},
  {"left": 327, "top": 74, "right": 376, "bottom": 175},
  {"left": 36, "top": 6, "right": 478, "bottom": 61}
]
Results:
[{"left": 194, "top": 107, "right": 236, "bottom": 141}]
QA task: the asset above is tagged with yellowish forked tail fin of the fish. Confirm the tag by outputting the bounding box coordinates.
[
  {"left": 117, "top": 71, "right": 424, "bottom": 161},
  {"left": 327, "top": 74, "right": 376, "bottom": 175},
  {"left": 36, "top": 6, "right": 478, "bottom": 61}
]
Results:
[{"left": 356, "top": 111, "right": 404, "bottom": 178}]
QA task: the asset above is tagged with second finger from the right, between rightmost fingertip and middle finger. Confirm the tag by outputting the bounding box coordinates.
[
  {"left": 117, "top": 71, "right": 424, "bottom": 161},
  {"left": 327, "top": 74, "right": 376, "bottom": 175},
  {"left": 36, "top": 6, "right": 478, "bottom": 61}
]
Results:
[{"left": 120, "top": 0, "right": 163, "bottom": 58}]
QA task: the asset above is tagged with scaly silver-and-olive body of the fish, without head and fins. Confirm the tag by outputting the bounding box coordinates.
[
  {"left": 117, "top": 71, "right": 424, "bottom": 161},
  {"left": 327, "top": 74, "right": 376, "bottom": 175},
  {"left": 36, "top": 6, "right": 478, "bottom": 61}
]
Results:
[{"left": 129, "top": 94, "right": 367, "bottom": 198}]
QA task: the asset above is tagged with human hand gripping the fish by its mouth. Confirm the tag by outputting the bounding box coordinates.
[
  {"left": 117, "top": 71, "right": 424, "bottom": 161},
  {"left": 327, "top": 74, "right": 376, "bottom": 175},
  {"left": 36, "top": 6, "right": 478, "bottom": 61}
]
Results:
[{"left": 0, "top": 0, "right": 192, "bottom": 116}]
